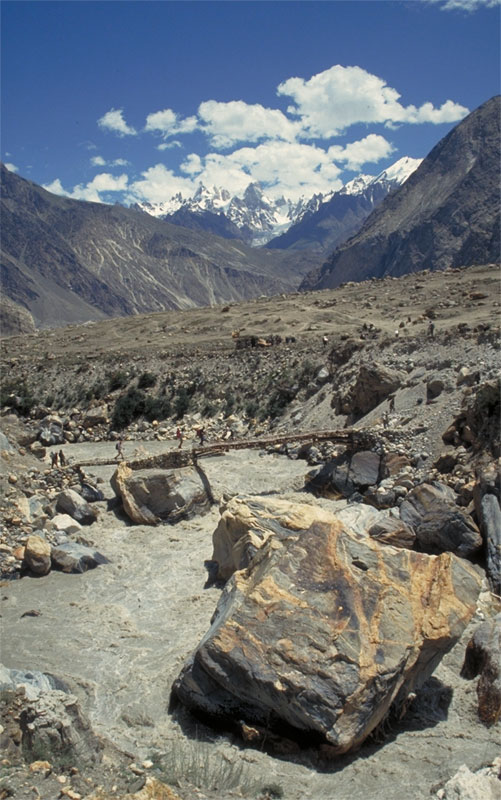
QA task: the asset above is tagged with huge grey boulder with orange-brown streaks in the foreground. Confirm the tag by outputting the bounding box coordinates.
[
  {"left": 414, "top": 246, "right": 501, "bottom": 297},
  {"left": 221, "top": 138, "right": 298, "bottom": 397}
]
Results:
[{"left": 172, "top": 522, "right": 481, "bottom": 754}]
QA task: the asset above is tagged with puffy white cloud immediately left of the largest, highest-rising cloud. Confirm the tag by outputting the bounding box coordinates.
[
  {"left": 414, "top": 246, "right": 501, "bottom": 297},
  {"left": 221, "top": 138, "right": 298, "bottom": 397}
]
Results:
[{"left": 198, "top": 100, "right": 300, "bottom": 148}]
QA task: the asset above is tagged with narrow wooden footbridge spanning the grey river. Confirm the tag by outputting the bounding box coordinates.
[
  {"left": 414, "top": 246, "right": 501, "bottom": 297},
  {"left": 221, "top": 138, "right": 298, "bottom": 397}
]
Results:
[{"left": 72, "top": 428, "right": 377, "bottom": 470}]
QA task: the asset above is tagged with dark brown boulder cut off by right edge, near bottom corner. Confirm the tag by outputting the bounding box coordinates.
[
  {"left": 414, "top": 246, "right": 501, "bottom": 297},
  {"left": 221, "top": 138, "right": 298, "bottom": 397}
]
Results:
[{"left": 461, "top": 614, "right": 501, "bottom": 726}]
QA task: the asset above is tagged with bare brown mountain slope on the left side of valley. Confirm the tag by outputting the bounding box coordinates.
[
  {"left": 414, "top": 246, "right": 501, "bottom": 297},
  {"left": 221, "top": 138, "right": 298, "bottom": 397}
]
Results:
[{"left": 1, "top": 166, "right": 320, "bottom": 327}]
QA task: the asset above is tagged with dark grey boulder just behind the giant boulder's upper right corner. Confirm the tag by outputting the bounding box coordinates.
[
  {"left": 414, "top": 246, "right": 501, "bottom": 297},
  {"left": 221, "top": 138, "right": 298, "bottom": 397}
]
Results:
[{"left": 400, "top": 482, "right": 482, "bottom": 558}]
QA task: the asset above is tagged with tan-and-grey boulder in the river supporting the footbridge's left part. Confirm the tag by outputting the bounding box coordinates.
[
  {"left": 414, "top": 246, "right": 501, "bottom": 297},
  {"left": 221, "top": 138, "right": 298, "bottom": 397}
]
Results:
[{"left": 111, "top": 462, "right": 212, "bottom": 525}]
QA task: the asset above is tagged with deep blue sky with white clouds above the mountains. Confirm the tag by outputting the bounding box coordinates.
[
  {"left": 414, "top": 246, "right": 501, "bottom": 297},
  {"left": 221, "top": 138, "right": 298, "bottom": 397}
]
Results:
[{"left": 1, "top": 0, "right": 500, "bottom": 203}]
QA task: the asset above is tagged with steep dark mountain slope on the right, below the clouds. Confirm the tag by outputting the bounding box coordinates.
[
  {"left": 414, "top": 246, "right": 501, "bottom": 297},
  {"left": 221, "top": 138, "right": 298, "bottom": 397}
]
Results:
[{"left": 301, "top": 97, "right": 501, "bottom": 289}]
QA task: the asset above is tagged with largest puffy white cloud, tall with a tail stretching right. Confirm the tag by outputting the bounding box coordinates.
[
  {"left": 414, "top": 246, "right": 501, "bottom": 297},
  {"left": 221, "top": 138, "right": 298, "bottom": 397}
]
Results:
[{"left": 277, "top": 64, "right": 468, "bottom": 138}]
